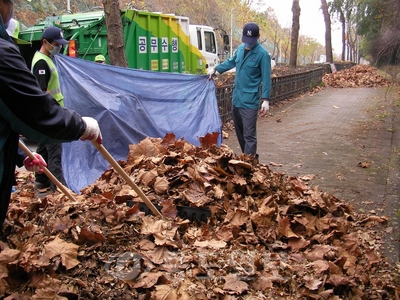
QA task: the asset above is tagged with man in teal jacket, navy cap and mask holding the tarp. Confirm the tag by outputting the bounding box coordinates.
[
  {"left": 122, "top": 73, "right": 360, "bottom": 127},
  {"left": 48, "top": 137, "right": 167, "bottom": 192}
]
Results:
[{"left": 208, "top": 23, "right": 271, "bottom": 161}]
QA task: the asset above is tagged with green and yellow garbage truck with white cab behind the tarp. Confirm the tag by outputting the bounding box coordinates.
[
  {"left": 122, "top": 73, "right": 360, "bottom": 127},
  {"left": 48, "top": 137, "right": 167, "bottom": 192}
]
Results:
[{"left": 19, "top": 9, "right": 223, "bottom": 74}]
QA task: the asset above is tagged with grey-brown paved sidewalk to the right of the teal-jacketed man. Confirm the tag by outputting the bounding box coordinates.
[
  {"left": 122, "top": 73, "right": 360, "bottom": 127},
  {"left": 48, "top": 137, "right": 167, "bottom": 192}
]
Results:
[{"left": 223, "top": 87, "right": 400, "bottom": 262}]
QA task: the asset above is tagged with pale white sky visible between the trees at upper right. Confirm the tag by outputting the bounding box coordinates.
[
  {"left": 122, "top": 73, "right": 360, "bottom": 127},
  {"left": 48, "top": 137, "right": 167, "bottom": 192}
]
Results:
[{"left": 262, "top": 0, "right": 342, "bottom": 54}]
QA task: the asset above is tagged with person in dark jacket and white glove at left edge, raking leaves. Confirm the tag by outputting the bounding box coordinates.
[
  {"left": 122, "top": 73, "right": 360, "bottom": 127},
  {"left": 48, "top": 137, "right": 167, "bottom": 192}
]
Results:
[{"left": 0, "top": 0, "right": 102, "bottom": 239}]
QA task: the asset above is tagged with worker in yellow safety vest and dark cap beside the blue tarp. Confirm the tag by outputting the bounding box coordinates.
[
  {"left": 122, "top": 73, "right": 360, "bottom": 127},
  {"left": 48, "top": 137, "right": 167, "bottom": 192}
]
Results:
[{"left": 32, "top": 26, "right": 68, "bottom": 191}]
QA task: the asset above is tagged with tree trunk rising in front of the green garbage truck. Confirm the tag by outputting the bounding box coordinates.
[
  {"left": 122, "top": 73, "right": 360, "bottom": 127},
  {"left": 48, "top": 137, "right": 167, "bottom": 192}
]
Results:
[{"left": 103, "top": 0, "right": 128, "bottom": 67}]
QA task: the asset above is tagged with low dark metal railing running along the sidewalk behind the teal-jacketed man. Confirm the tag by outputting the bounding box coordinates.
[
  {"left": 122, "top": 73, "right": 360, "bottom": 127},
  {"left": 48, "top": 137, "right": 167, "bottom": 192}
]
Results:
[{"left": 216, "top": 65, "right": 331, "bottom": 123}]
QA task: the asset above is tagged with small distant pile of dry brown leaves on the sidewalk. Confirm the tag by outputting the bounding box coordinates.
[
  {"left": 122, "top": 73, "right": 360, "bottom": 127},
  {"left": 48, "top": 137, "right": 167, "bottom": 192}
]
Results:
[{"left": 322, "top": 65, "right": 390, "bottom": 88}]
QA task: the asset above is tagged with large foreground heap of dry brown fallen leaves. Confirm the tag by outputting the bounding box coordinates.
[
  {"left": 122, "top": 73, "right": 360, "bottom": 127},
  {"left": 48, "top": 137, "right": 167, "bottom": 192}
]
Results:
[{"left": 0, "top": 134, "right": 399, "bottom": 299}]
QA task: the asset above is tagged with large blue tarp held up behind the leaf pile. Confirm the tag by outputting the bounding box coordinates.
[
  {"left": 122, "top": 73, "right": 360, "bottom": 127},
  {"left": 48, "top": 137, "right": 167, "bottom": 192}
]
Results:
[{"left": 55, "top": 55, "right": 222, "bottom": 193}]
